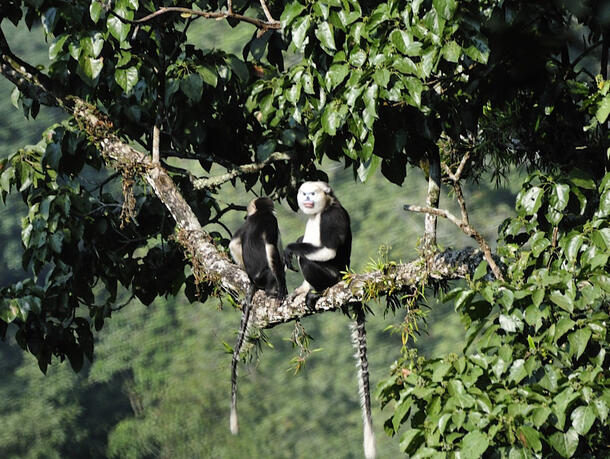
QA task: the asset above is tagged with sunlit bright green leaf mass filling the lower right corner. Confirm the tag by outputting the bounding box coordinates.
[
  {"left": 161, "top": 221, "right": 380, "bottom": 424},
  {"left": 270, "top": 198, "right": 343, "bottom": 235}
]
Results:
[{"left": 378, "top": 173, "right": 610, "bottom": 457}]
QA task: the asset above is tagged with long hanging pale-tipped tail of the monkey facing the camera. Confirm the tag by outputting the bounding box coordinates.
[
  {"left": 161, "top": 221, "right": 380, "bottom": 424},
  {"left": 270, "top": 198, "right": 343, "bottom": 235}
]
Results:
[{"left": 352, "top": 309, "right": 377, "bottom": 459}]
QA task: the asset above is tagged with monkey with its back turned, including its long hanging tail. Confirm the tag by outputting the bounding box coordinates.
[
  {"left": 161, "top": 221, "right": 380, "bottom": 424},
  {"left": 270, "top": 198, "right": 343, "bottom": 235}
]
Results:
[{"left": 229, "top": 197, "right": 287, "bottom": 434}]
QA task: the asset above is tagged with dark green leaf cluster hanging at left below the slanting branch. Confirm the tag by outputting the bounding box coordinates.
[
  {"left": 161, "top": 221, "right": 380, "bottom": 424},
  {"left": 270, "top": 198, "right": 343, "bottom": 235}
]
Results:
[{"left": 0, "top": 123, "right": 200, "bottom": 371}]
